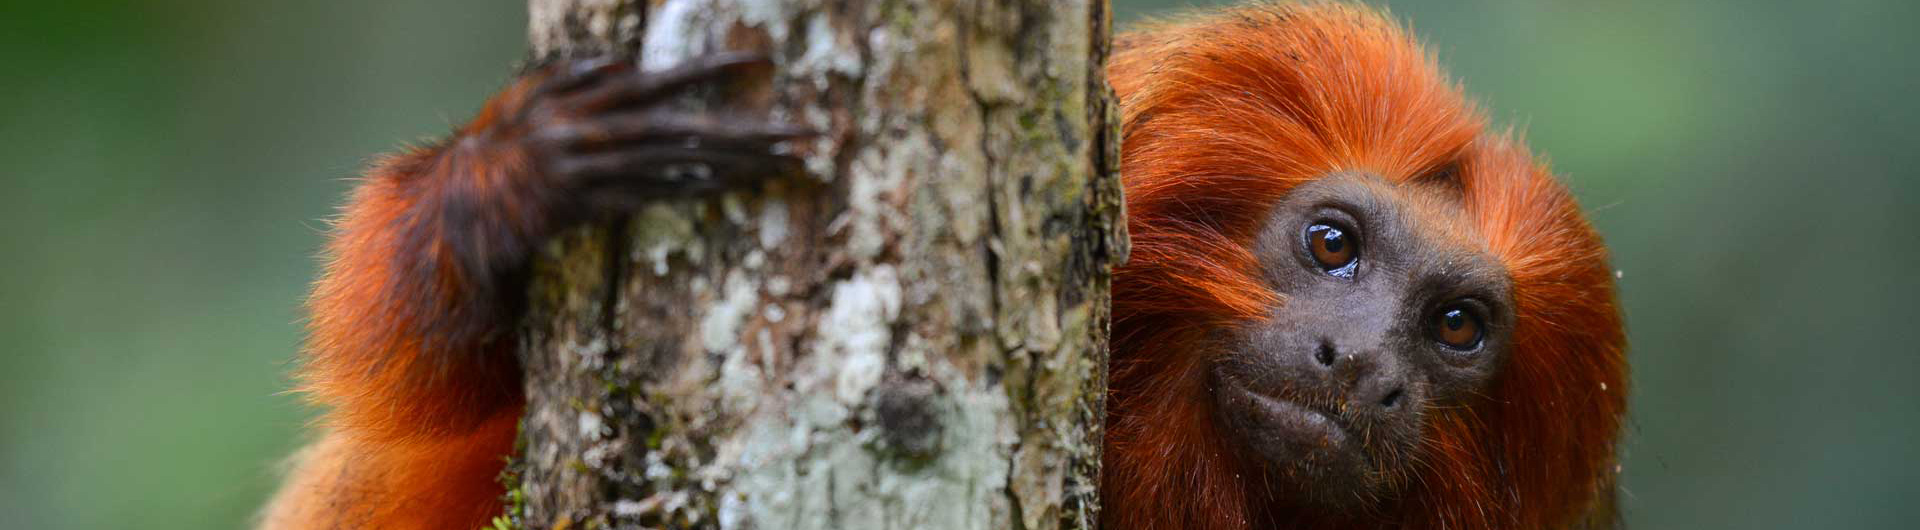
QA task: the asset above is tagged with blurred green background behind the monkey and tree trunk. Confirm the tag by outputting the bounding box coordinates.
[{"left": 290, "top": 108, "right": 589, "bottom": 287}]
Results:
[{"left": 0, "top": 0, "right": 1920, "bottom": 530}]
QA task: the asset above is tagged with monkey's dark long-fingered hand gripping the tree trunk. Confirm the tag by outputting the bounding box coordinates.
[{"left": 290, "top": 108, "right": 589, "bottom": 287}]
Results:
[{"left": 453, "top": 52, "right": 808, "bottom": 299}]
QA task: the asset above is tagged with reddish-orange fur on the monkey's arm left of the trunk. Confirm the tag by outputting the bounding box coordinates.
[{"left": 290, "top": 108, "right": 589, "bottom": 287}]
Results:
[{"left": 261, "top": 71, "right": 543, "bottom": 530}]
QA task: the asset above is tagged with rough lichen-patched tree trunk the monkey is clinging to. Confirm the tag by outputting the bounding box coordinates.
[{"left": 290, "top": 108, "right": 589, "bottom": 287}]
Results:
[{"left": 509, "top": 0, "right": 1125, "bottom": 528}]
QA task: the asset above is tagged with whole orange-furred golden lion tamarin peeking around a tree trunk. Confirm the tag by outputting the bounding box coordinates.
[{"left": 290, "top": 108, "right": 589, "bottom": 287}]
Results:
[{"left": 263, "top": 4, "right": 1626, "bottom": 530}]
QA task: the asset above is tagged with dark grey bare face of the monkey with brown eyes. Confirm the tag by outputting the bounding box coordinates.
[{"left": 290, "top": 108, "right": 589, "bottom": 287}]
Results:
[{"left": 1213, "top": 173, "right": 1513, "bottom": 511}]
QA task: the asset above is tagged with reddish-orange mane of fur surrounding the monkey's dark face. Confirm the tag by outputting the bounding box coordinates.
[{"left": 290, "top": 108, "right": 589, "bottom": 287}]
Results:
[{"left": 1102, "top": 4, "right": 1626, "bottom": 530}]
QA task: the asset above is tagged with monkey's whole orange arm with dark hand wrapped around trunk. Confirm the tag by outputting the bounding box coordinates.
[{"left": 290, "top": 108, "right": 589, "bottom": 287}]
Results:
[{"left": 263, "top": 54, "right": 799, "bottom": 530}]
